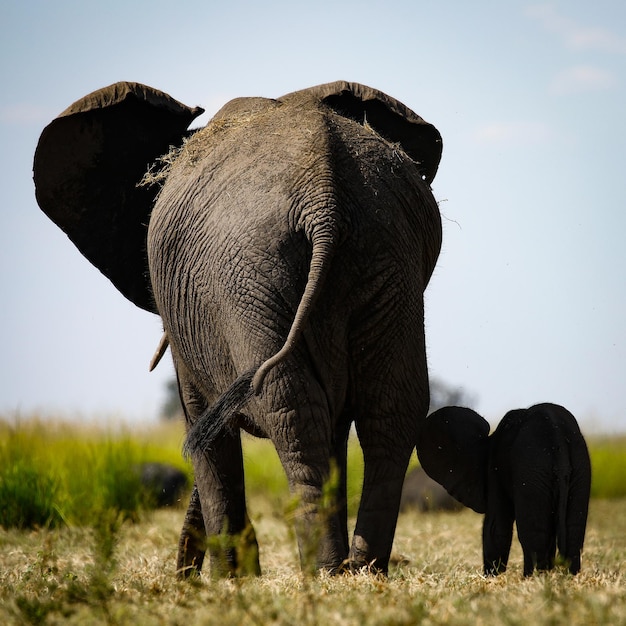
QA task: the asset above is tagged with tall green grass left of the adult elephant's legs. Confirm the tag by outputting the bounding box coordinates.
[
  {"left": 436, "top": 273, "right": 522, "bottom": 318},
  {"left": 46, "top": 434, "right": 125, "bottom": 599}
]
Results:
[{"left": 0, "top": 419, "right": 190, "bottom": 528}]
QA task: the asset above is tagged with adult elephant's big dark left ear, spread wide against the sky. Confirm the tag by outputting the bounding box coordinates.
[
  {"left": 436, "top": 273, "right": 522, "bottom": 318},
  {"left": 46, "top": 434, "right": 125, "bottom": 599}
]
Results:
[{"left": 33, "top": 82, "right": 203, "bottom": 311}]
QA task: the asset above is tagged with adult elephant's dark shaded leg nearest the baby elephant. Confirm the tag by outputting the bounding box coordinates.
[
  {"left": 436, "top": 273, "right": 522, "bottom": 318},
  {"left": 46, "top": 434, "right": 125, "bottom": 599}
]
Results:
[{"left": 349, "top": 336, "right": 428, "bottom": 574}]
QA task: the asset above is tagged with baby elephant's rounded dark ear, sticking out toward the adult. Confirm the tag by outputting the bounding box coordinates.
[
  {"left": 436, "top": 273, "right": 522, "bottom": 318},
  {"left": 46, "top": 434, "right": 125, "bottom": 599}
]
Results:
[{"left": 417, "top": 406, "right": 489, "bottom": 513}]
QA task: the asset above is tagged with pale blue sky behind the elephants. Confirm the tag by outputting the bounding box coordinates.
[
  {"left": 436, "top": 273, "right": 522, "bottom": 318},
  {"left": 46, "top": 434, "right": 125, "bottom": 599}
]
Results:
[{"left": 0, "top": 0, "right": 626, "bottom": 433}]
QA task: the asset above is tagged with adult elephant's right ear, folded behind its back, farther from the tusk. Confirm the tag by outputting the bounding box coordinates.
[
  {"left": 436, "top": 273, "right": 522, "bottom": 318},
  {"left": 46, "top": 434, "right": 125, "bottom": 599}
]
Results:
[{"left": 286, "top": 80, "right": 443, "bottom": 185}]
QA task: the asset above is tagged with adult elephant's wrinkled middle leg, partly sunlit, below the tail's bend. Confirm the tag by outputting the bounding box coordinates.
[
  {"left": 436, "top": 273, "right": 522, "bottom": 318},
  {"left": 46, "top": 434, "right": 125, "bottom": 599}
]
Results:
[{"left": 259, "top": 359, "right": 348, "bottom": 573}]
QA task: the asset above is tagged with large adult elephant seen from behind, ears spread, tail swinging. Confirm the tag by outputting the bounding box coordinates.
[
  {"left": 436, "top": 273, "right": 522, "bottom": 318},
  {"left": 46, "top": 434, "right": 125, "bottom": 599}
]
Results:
[{"left": 34, "top": 81, "right": 442, "bottom": 574}]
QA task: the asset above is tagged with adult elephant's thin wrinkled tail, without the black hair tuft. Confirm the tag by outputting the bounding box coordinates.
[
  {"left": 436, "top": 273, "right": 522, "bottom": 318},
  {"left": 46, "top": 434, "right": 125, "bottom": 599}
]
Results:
[{"left": 252, "top": 220, "right": 337, "bottom": 395}]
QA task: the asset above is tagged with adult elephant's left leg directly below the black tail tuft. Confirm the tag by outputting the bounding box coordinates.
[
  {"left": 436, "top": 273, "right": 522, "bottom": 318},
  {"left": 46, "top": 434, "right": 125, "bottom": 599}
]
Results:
[{"left": 192, "top": 432, "right": 261, "bottom": 577}]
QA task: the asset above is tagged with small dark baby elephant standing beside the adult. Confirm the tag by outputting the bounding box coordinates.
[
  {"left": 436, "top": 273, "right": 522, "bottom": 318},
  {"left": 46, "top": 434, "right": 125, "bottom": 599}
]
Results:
[{"left": 417, "top": 404, "right": 591, "bottom": 576}]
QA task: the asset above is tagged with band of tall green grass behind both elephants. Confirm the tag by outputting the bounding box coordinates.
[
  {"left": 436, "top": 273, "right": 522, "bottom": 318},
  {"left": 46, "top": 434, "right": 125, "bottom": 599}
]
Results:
[{"left": 0, "top": 419, "right": 626, "bottom": 528}]
